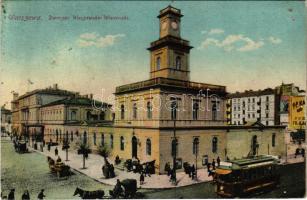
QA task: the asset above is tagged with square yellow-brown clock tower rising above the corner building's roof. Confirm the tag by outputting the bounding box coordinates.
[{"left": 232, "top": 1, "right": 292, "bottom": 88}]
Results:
[{"left": 148, "top": 6, "right": 193, "bottom": 81}]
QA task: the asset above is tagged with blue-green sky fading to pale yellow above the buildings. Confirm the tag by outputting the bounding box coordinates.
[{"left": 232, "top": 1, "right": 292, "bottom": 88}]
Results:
[{"left": 0, "top": 1, "right": 307, "bottom": 108}]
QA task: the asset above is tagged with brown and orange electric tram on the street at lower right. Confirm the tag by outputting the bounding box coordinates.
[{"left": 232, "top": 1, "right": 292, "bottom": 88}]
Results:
[{"left": 215, "top": 155, "right": 280, "bottom": 197}]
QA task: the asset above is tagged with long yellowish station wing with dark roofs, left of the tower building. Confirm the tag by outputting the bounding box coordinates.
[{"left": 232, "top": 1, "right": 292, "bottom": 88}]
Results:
[{"left": 12, "top": 84, "right": 113, "bottom": 149}]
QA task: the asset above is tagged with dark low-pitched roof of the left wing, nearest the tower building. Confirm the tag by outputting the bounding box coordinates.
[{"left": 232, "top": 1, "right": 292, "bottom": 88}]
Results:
[{"left": 42, "top": 97, "right": 112, "bottom": 107}]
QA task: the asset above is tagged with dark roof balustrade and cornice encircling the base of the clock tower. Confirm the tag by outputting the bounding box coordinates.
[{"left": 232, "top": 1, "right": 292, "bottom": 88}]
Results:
[{"left": 115, "top": 77, "right": 226, "bottom": 95}]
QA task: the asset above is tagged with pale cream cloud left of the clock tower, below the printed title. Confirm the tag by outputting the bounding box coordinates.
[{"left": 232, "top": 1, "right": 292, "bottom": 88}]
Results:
[{"left": 77, "top": 33, "right": 125, "bottom": 48}]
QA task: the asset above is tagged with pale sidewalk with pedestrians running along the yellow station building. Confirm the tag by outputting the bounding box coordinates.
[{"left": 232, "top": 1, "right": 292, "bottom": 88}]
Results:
[{"left": 31, "top": 145, "right": 212, "bottom": 189}]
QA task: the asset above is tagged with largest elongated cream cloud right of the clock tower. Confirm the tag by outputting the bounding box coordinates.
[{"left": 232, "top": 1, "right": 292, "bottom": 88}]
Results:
[{"left": 198, "top": 34, "right": 264, "bottom": 52}]
